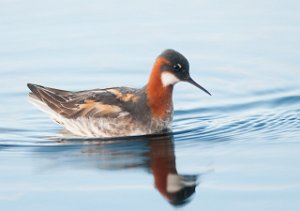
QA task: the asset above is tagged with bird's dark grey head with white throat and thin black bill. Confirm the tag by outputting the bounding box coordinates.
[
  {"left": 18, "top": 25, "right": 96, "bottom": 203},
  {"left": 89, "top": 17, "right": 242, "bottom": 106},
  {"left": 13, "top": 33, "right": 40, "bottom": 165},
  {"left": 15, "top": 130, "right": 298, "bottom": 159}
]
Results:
[{"left": 158, "top": 49, "right": 211, "bottom": 95}]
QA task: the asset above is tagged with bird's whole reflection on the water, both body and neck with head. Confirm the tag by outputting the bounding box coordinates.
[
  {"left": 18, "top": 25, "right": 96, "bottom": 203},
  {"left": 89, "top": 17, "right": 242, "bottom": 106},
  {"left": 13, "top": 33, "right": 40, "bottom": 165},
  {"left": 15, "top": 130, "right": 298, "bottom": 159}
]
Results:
[{"left": 48, "top": 134, "right": 198, "bottom": 206}]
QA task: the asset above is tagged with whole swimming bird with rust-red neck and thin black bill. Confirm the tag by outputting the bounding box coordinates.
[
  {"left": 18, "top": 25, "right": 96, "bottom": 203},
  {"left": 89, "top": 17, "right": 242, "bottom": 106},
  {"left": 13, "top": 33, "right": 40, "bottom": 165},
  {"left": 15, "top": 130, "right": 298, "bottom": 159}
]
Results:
[{"left": 27, "top": 49, "right": 211, "bottom": 138}]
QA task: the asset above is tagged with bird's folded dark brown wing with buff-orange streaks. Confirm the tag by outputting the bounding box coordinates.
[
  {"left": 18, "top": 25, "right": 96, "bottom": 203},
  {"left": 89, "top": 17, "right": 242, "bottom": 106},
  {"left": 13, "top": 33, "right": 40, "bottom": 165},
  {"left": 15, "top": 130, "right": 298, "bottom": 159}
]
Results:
[{"left": 28, "top": 84, "right": 139, "bottom": 118}]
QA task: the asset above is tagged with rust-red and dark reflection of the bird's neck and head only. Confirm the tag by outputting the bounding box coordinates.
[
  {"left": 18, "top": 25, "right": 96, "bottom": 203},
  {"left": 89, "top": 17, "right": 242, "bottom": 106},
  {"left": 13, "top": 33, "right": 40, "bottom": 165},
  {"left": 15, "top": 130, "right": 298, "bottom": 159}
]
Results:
[{"left": 149, "top": 135, "right": 197, "bottom": 205}]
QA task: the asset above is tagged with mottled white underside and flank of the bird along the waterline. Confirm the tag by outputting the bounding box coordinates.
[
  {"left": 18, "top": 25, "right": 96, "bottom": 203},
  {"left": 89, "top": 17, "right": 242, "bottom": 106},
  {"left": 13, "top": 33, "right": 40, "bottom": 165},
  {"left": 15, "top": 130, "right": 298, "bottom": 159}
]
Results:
[{"left": 29, "top": 97, "right": 170, "bottom": 138}]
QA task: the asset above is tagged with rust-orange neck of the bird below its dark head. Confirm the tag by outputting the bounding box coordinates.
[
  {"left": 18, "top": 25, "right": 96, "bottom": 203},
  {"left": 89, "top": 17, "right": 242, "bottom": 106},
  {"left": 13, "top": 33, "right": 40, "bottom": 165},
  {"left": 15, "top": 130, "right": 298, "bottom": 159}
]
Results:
[{"left": 146, "top": 58, "right": 173, "bottom": 119}]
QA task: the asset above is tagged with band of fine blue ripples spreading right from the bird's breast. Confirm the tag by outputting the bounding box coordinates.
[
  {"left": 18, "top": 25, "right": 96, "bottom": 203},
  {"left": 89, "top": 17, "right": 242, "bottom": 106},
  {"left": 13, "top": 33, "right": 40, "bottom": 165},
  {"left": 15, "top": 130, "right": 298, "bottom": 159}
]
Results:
[{"left": 174, "top": 92, "right": 300, "bottom": 145}]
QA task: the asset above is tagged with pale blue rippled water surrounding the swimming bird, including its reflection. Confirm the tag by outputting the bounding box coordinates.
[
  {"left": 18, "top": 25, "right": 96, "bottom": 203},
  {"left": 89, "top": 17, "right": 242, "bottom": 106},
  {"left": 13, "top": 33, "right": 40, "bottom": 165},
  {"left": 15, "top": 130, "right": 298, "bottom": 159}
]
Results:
[{"left": 0, "top": 0, "right": 300, "bottom": 210}]
